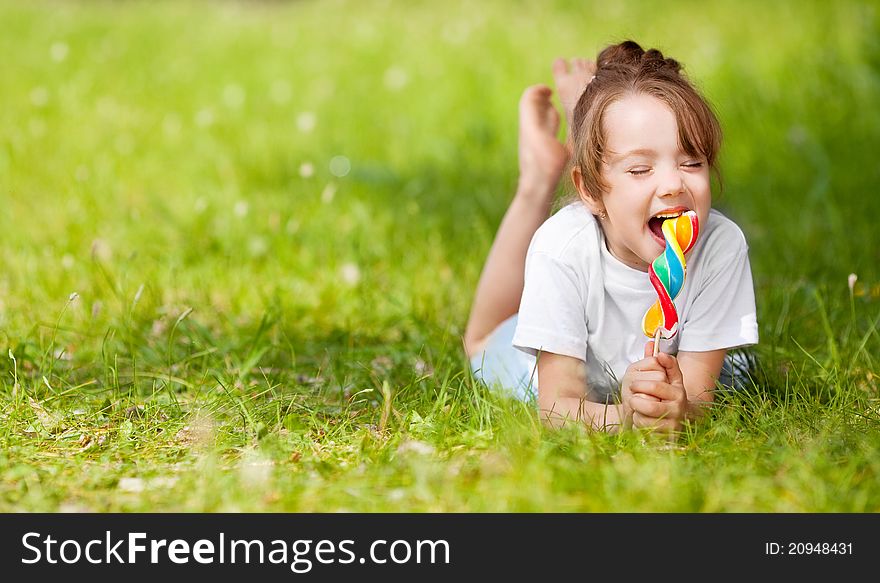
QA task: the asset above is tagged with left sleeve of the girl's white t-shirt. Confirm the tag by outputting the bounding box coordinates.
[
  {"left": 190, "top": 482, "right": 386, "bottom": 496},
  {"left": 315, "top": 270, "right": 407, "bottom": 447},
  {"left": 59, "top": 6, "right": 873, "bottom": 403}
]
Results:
[{"left": 513, "top": 252, "right": 587, "bottom": 360}]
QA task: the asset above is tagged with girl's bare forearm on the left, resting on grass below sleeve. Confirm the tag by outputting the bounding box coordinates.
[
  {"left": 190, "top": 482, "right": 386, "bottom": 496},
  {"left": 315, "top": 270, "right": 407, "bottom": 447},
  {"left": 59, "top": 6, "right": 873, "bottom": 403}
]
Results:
[{"left": 538, "top": 352, "right": 626, "bottom": 433}]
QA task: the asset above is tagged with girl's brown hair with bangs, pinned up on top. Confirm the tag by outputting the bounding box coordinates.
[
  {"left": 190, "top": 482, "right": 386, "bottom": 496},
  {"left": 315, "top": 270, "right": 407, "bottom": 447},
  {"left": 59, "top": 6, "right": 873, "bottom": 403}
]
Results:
[{"left": 571, "top": 40, "right": 721, "bottom": 199}]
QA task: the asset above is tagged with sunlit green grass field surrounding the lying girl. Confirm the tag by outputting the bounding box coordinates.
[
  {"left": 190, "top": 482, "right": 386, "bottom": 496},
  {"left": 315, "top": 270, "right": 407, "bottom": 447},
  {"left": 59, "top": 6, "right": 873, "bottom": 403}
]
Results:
[{"left": 0, "top": 0, "right": 880, "bottom": 512}]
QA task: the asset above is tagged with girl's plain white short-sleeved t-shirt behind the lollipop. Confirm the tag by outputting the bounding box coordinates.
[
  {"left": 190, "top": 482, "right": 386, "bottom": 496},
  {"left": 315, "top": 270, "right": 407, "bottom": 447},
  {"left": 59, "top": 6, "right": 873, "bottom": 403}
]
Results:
[{"left": 513, "top": 202, "right": 758, "bottom": 401}]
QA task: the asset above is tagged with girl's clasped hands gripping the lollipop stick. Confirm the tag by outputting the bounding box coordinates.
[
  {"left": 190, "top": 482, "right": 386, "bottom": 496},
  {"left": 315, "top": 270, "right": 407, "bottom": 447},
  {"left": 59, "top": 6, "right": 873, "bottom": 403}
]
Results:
[{"left": 628, "top": 350, "right": 689, "bottom": 434}]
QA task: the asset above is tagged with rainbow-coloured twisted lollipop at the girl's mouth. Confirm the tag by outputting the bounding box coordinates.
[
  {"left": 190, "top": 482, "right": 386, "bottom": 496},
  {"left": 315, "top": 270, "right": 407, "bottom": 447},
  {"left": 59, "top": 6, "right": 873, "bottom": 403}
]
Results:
[{"left": 642, "top": 211, "right": 700, "bottom": 342}]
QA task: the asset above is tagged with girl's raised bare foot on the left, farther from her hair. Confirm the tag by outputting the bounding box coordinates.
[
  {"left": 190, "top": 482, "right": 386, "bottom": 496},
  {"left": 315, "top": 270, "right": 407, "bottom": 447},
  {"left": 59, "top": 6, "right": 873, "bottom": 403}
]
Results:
[{"left": 519, "top": 85, "right": 569, "bottom": 197}]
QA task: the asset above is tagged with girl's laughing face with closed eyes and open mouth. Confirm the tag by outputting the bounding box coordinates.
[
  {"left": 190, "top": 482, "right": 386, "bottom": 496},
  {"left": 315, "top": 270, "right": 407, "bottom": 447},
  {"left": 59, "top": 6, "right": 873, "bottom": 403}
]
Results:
[{"left": 590, "top": 94, "right": 712, "bottom": 271}]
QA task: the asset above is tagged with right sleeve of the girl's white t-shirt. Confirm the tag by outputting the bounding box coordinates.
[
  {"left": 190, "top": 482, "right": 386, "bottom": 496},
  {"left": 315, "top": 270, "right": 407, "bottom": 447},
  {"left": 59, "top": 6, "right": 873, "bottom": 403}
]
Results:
[{"left": 678, "top": 247, "right": 758, "bottom": 352}]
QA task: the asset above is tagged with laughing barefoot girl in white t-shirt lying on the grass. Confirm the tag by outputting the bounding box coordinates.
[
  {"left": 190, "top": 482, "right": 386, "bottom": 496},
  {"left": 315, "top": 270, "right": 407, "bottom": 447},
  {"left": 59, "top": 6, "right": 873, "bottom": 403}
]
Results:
[{"left": 464, "top": 41, "right": 758, "bottom": 433}]
